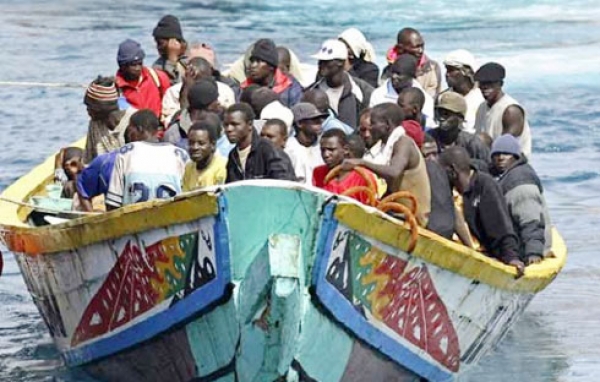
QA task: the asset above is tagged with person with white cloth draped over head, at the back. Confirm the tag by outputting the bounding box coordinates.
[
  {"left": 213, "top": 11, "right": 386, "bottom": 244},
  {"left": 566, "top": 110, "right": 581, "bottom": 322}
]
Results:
[{"left": 338, "top": 28, "right": 379, "bottom": 88}]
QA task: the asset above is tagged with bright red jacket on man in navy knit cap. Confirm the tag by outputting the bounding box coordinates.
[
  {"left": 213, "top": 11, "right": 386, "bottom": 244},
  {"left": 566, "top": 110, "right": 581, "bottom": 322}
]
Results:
[{"left": 115, "top": 66, "right": 171, "bottom": 118}]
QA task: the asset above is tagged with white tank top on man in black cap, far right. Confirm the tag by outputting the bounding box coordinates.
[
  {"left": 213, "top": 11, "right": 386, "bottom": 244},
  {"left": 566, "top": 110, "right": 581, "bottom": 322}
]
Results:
[{"left": 475, "top": 94, "right": 531, "bottom": 158}]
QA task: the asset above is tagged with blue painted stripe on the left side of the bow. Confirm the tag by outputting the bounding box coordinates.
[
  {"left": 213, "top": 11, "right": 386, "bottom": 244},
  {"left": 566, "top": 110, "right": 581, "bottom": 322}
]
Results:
[{"left": 63, "top": 197, "right": 231, "bottom": 367}]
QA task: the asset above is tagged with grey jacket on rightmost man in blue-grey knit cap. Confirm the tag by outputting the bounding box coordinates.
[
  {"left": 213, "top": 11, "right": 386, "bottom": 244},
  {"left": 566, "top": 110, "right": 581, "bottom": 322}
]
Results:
[{"left": 497, "top": 157, "right": 551, "bottom": 260}]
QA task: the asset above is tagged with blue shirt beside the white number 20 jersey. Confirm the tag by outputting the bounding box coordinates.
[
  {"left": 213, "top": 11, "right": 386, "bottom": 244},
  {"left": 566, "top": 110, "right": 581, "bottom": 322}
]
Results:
[{"left": 77, "top": 150, "right": 119, "bottom": 200}]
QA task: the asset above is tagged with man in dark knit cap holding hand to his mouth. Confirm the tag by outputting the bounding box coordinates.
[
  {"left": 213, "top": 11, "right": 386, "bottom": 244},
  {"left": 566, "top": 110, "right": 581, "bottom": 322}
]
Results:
[{"left": 152, "top": 15, "right": 186, "bottom": 85}]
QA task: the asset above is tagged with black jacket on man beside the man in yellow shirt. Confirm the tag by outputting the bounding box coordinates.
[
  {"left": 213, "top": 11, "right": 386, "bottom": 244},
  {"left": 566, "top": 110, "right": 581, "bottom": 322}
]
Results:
[{"left": 225, "top": 129, "right": 296, "bottom": 183}]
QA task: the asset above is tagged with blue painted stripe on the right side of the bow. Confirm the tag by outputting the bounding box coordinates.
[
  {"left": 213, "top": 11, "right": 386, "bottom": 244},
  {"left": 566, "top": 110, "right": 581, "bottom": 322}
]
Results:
[{"left": 313, "top": 212, "right": 454, "bottom": 382}]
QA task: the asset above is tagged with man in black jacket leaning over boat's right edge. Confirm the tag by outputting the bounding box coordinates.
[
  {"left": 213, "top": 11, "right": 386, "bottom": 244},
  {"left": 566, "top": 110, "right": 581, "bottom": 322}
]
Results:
[{"left": 439, "top": 146, "right": 525, "bottom": 277}]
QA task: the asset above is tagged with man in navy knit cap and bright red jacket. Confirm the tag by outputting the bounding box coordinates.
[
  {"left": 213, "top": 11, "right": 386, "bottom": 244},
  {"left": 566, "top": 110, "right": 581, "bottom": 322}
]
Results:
[{"left": 115, "top": 39, "right": 171, "bottom": 117}]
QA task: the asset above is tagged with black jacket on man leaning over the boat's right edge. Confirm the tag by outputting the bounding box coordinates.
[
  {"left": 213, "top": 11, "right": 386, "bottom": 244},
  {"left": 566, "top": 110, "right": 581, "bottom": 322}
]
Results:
[{"left": 463, "top": 170, "right": 519, "bottom": 263}]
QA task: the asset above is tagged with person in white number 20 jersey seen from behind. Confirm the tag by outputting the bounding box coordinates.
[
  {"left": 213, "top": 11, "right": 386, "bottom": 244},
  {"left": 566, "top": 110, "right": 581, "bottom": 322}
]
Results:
[{"left": 105, "top": 109, "right": 189, "bottom": 210}]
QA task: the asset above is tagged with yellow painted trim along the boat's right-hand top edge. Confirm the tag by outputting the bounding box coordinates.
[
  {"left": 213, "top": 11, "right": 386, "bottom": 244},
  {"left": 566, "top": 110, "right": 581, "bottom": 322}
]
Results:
[{"left": 335, "top": 203, "right": 567, "bottom": 293}]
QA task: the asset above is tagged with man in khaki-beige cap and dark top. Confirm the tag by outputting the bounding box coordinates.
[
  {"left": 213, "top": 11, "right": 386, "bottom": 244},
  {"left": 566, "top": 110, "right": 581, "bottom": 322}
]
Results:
[{"left": 429, "top": 91, "right": 490, "bottom": 171}]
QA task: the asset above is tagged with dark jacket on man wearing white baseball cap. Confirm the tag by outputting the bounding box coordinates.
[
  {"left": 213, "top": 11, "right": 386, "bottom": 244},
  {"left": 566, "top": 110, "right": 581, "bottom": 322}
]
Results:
[{"left": 306, "top": 73, "right": 373, "bottom": 129}]
